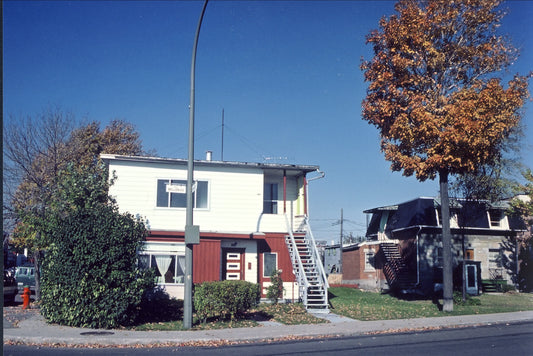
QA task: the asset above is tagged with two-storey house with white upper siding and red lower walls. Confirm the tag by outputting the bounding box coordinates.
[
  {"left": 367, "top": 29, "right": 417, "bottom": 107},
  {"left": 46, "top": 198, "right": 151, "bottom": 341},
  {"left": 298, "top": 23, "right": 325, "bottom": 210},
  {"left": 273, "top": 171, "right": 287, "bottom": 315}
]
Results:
[{"left": 97, "top": 154, "right": 327, "bottom": 309}]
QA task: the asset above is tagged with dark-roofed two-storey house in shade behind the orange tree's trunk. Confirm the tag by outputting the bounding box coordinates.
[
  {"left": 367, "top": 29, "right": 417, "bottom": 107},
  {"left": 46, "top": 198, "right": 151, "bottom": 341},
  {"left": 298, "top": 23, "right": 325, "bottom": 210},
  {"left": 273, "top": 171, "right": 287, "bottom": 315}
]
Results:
[{"left": 343, "top": 198, "right": 523, "bottom": 295}]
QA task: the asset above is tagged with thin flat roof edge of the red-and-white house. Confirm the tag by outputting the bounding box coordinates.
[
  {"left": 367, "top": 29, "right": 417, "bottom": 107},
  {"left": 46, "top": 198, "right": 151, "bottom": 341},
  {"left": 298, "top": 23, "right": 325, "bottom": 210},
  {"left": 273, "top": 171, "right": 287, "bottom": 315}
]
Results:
[{"left": 100, "top": 154, "right": 320, "bottom": 173}]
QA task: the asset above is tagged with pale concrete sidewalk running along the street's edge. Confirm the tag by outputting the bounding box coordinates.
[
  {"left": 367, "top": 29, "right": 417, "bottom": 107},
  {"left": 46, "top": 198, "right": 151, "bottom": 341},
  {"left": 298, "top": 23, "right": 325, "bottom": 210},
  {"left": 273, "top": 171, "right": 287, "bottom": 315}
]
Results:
[{"left": 3, "top": 311, "right": 533, "bottom": 347}]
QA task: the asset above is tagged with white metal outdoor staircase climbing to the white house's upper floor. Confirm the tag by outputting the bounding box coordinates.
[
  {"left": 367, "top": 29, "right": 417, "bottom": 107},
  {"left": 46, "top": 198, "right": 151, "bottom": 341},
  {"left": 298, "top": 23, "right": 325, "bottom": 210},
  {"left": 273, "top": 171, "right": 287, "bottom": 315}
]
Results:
[{"left": 285, "top": 216, "right": 329, "bottom": 313}]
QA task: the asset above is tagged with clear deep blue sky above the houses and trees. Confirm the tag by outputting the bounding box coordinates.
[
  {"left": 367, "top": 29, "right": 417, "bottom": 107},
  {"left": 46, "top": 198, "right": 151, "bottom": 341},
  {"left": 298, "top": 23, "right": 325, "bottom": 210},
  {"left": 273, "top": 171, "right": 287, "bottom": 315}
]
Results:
[{"left": 3, "top": 0, "right": 533, "bottom": 241}]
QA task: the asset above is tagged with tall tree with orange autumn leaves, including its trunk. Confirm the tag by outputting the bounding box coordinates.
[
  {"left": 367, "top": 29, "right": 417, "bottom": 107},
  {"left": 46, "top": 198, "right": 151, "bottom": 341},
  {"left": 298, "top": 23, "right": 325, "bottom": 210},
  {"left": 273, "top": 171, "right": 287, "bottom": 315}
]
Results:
[{"left": 361, "top": 0, "right": 530, "bottom": 311}]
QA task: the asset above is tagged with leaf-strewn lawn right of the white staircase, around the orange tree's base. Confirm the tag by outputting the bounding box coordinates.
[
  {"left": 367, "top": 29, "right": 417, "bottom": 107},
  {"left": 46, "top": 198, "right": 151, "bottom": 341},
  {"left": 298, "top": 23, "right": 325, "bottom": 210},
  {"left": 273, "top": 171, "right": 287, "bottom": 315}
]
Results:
[{"left": 329, "top": 288, "right": 533, "bottom": 320}]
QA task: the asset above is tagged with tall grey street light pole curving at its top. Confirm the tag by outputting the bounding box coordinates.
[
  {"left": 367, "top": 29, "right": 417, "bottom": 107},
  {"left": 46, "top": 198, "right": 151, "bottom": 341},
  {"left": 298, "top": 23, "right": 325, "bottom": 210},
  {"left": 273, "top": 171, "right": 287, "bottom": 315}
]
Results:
[{"left": 183, "top": 0, "right": 208, "bottom": 329}]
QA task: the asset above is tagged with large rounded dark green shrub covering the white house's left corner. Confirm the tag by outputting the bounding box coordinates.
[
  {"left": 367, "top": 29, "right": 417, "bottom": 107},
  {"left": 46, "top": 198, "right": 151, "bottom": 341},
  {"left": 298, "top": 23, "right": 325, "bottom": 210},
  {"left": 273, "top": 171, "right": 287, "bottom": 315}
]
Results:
[{"left": 41, "top": 204, "right": 154, "bottom": 328}]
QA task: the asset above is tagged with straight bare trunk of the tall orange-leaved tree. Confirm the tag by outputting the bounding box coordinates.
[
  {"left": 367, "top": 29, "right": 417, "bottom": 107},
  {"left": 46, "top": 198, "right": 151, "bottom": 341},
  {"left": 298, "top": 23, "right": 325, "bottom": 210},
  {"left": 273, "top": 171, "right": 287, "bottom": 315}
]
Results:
[{"left": 439, "top": 171, "right": 453, "bottom": 312}]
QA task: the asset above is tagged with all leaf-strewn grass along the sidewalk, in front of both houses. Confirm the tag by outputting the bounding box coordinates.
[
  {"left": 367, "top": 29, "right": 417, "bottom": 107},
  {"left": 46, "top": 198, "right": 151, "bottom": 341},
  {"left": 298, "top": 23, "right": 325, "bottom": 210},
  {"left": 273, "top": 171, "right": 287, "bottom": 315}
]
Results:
[{"left": 133, "top": 287, "right": 533, "bottom": 330}]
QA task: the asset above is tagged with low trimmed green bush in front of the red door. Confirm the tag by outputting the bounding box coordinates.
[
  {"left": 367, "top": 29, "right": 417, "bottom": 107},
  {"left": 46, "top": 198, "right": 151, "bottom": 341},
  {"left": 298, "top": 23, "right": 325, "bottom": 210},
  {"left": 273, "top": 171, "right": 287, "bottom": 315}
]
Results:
[{"left": 194, "top": 281, "right": 260, "bottom": 323}]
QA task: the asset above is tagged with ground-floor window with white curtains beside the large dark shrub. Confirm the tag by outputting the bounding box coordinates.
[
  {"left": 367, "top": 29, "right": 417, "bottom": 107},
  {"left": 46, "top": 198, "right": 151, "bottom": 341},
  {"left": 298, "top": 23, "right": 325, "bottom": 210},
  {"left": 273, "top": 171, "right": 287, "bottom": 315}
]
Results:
[{"left": 139, "top": 242, "right": 185, "bottom": 284}]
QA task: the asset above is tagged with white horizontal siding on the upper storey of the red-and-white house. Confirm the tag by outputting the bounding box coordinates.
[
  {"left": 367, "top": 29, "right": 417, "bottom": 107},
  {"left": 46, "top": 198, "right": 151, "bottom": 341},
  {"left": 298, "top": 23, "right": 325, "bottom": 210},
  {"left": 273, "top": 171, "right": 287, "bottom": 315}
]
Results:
[{"left": 109, "top": 160, "right": 300, "bottom": 233}]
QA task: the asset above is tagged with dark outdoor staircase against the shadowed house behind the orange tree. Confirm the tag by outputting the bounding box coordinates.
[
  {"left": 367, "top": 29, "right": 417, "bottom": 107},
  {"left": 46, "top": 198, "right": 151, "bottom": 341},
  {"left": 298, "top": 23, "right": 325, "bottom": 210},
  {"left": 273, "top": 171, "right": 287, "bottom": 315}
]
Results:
[{"left": 381, "top": 242, "right": 416, "bottom": 292}]
